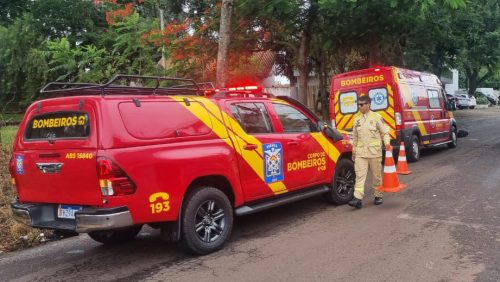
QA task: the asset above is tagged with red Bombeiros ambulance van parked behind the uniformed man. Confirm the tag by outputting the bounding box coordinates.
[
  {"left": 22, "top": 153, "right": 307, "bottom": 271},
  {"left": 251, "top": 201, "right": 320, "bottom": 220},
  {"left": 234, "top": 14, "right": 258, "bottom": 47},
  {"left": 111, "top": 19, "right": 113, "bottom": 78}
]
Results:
[{"left": 330, "top": 66, "right": 457, "bottom": 162}]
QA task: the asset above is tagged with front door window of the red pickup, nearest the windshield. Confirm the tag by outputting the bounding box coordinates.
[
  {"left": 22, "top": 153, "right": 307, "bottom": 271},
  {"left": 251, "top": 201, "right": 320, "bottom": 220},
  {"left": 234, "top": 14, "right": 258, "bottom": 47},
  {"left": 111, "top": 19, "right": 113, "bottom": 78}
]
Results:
[{"left": 273, "top": 103, "right": 315, "bottom": 133}]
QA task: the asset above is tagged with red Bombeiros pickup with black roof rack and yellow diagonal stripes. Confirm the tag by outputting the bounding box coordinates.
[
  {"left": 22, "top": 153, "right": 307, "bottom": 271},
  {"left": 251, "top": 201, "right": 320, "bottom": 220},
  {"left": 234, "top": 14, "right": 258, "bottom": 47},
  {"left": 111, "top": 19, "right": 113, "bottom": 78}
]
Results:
[{"left": 9, "top": 75, "right": 355, "bottom": 254}]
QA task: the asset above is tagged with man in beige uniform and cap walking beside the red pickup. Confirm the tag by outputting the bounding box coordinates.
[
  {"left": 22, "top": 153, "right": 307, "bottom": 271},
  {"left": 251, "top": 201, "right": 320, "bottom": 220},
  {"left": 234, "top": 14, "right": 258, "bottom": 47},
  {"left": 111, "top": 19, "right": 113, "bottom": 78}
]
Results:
[{"left": 349, "top": 95, "right": 392, "bottom": 209}]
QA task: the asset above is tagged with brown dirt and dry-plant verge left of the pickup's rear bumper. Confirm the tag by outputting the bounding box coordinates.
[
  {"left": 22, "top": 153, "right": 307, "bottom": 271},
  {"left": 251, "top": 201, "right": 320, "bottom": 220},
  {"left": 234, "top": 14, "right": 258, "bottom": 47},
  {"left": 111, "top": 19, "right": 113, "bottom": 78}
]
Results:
[{"left": 0, "top": 148, "right": 52, "bottom": 253}]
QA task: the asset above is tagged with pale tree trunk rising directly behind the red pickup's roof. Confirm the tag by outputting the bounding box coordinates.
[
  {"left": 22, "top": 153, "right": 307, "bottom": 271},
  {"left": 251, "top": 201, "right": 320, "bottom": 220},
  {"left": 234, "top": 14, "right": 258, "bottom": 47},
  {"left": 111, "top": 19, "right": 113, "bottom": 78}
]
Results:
[{"left": 216, "top": 0, "right": 234, "bottom": 87}]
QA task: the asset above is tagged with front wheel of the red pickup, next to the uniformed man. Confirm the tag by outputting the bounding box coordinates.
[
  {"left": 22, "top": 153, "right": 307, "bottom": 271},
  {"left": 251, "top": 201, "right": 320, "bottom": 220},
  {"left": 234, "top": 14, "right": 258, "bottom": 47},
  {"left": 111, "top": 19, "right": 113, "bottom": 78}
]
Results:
[{"left": 325, "top": 159, "right": 356, "bottom": 205}]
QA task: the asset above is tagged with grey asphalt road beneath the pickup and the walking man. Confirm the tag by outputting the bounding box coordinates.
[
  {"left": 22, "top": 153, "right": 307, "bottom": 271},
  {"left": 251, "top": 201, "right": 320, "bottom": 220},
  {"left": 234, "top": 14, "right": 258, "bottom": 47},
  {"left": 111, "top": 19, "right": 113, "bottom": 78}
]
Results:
[{"left": 0, "top": 109, "right": 500, "bottom": 281}]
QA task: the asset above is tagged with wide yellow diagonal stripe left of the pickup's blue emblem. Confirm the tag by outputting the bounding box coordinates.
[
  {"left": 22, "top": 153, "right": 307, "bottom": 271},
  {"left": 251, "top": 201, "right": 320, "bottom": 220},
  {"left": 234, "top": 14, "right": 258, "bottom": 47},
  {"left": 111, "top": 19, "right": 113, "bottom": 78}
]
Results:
[{"left": 172, "top": 97, "right": 288, "bottom": 194}]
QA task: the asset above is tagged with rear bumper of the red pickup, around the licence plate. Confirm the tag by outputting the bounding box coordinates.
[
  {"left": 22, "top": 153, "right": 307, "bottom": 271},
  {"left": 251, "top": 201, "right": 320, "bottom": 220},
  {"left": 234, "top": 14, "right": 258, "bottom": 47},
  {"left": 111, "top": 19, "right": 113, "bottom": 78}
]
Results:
[{"left": 11, "top": 202, "right": 134, "bottom": 233}]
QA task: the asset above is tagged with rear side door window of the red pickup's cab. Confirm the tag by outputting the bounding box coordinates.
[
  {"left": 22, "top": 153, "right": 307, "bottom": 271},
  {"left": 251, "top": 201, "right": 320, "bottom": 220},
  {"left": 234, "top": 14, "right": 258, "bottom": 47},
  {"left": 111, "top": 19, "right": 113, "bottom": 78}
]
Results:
[{"left": 230, "top": 103, "right": 274, "bottom": 134}]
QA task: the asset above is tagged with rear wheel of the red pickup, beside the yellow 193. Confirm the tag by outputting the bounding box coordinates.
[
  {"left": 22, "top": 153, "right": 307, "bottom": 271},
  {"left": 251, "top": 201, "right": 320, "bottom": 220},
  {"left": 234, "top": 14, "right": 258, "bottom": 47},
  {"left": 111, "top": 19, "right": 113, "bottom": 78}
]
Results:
[{"left": 181, "top": 187, "right": 233, "bottom": 255}]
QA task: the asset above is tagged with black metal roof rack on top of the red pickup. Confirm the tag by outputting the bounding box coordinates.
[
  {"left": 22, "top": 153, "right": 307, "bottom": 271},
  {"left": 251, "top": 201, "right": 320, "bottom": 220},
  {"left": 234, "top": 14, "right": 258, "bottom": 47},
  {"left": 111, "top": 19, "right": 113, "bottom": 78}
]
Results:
[{"left": 40, "top": 74, "right": 214, "bottom": 98}]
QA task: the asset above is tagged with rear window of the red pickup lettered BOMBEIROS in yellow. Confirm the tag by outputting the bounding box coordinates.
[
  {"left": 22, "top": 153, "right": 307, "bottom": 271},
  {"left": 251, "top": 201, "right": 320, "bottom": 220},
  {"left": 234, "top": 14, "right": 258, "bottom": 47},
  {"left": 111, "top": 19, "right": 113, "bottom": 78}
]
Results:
[{"left": 24, "top": 112, "right": 90, "bottom": 140}]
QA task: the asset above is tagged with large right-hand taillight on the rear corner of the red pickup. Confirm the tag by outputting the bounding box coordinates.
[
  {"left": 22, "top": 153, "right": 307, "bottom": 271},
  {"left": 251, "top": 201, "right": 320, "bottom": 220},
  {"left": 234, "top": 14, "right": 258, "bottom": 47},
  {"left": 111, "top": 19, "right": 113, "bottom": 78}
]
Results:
[{"left": 97, "top": 157, "right": 137, "bottom": 196}]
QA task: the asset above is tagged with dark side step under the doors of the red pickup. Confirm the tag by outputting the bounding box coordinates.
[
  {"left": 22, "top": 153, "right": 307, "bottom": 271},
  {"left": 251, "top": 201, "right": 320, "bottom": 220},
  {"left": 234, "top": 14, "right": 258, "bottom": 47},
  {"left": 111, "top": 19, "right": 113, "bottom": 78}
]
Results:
[{"left": 235, "top": 185, "right": 330, "bottom": 216}]
